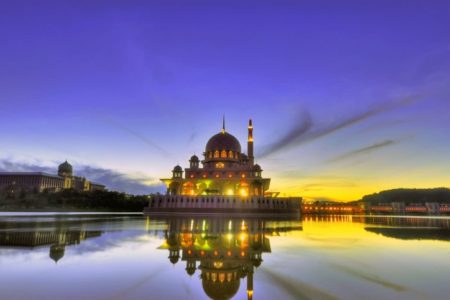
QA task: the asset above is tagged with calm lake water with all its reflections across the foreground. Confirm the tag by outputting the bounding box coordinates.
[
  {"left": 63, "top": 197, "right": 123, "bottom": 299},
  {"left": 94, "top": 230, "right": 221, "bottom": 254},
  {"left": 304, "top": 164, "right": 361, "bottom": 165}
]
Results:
[{"left": 0, "top": 213, "right": 450, "bottom": 300}]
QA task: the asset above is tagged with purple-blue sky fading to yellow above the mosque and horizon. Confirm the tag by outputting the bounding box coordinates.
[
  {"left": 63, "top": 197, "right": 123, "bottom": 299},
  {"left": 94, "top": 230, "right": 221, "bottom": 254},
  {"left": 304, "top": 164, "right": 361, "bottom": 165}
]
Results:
[{"left": 0, "top": 0, "right": 450, "bottom": 200}]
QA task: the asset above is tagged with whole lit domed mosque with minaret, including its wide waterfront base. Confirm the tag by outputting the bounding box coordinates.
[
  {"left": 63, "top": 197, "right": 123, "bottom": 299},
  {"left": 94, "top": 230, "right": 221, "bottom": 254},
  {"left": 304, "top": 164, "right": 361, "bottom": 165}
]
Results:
[{"left": 144, "top": 119, "right": 301, "bottom": 218}]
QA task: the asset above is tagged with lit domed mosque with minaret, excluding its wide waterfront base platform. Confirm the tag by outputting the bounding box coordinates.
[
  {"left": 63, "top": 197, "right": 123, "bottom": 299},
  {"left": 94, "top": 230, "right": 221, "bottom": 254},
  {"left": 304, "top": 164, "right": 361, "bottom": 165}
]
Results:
[{"left": 161, "top": 119, "right": 270, "bottom": 197}]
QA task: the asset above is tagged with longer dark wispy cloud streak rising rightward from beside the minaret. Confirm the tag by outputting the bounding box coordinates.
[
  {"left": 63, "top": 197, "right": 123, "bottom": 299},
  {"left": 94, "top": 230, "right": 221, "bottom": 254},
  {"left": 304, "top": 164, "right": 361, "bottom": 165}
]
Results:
[{"left": 260, "top": 96, "right": 420, "bottom": 157}]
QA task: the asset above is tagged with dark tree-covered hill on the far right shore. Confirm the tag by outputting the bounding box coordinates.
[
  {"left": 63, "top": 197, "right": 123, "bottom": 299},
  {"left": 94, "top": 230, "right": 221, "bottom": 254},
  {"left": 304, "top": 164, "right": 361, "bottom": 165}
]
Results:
[{"left": 360, "top": 188, "right": 450, "bottom": 203}]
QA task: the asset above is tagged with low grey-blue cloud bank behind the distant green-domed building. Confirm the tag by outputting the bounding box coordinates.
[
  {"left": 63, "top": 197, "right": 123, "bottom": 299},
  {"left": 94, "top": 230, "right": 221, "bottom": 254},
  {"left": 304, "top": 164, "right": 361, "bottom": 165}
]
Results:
[{"left": 0, "top": 159, "right": 163, "bottom": 194}]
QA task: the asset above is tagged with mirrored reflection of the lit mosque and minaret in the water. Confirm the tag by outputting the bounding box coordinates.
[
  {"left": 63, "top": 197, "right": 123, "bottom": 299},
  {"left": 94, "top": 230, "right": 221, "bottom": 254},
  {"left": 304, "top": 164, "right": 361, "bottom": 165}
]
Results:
[{"left": 159, "top": 219, "right": 301, "bottom": 299}]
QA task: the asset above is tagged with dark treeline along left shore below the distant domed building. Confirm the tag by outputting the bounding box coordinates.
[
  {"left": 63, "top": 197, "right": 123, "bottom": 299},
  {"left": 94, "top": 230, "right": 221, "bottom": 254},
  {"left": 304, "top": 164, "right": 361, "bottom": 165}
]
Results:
[{"left": 0, "top": 190, "right": 148, "bottom": 212}]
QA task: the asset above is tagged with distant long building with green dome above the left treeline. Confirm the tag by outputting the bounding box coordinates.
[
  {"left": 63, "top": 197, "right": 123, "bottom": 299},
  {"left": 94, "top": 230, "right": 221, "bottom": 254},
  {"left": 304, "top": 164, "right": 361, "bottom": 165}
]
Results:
[{"left": 0, "top": 161, "right": 105, "bottom": 193}]
